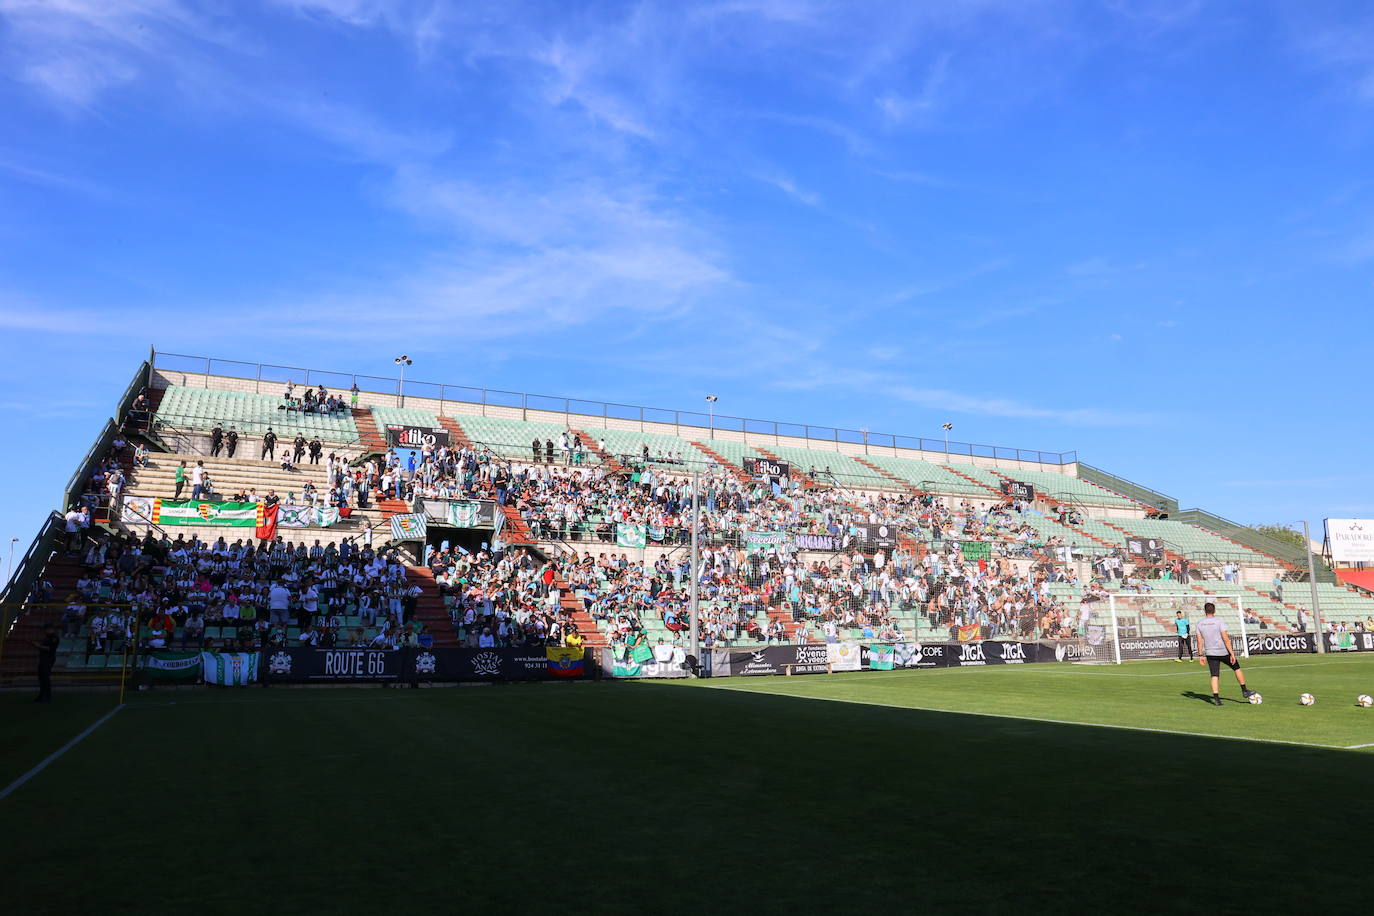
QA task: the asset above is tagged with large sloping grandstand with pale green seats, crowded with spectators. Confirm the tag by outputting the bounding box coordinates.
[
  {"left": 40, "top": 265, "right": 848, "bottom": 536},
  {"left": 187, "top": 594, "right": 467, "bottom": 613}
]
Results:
[{"left": 0, "top": 353, "right": 1374, "bottom": 681}]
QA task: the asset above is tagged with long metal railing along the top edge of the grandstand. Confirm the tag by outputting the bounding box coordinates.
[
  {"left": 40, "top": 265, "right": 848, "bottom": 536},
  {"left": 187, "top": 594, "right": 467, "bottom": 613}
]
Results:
[{"left": 153, "top": 352, "right": 1079, "bottom": 466}]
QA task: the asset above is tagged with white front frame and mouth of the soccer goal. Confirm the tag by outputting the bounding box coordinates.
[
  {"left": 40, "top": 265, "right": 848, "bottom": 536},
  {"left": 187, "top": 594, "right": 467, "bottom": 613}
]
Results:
[{"left": 1102, "top": 592, "right": 1249, "bottom": 665}]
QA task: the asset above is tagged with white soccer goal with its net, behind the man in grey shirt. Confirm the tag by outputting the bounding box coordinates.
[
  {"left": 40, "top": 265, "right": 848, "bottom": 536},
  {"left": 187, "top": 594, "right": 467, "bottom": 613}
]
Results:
[{"left": 1080, "top": 592, "right": 1250, "bottom": 665}]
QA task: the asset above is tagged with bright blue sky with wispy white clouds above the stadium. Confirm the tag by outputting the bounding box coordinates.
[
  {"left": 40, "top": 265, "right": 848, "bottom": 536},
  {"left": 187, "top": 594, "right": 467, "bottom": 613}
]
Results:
[{"left": 0, "top": 0, "right": 1374, "bottom": 563}]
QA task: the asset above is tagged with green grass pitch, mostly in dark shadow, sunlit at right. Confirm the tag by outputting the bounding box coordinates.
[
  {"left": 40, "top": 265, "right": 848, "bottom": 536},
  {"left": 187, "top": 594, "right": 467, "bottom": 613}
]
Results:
[{"left": 0, "top": 656, "right": 1374, "bottom": 915}]
